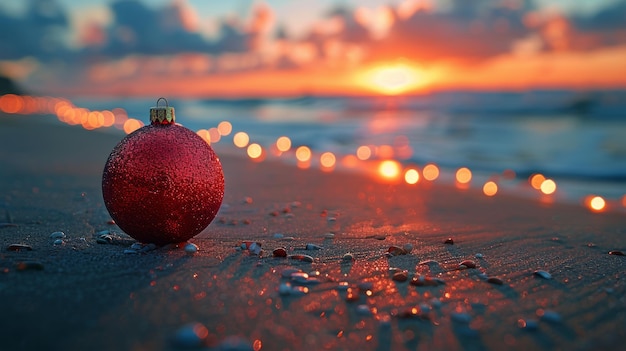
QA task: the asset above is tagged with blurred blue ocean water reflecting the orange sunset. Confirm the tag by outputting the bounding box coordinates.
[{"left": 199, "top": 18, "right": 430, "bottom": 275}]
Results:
[{"left": 74, "top": 90, "right": 626, "bottom": 206}]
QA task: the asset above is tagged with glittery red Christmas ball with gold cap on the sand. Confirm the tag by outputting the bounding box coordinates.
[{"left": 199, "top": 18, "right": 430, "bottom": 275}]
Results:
[{"left": 102, "top": 98, "right": 224, "bottom": 245}]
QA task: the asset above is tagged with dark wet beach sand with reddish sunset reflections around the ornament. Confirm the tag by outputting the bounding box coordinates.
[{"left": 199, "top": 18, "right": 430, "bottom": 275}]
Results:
[{"left": 0, "top": 116, "right": 626, "bottom": 350}]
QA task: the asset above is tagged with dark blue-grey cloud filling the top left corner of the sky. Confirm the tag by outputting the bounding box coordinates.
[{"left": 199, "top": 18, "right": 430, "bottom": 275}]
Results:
[{"left": 0, "top": 0, "right": 69, "bottom": 61}]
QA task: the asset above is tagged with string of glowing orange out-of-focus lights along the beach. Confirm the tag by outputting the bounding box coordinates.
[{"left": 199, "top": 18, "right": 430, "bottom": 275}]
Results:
[{"left": 0, "top": 94, "right": 626, "bottom": 212}]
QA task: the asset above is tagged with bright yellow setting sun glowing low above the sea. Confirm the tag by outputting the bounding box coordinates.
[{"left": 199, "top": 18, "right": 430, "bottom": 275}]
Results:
[{"left": 363, "top": 63, "right": 427, "bottom": 95}]
